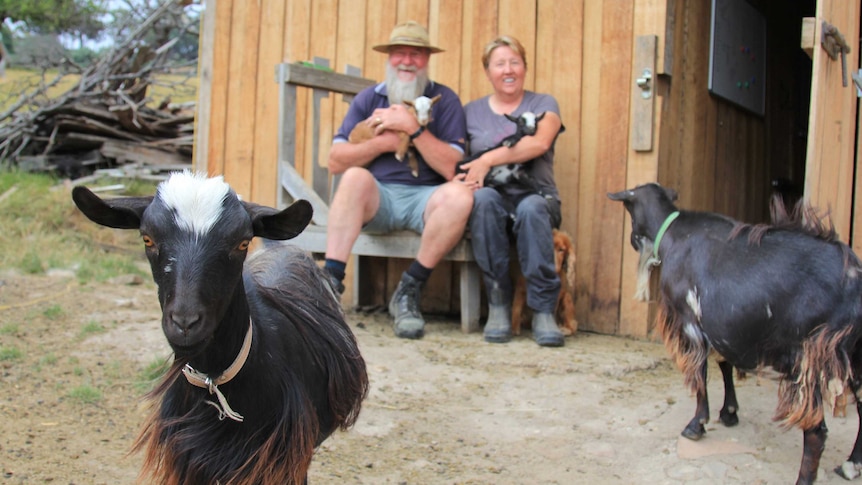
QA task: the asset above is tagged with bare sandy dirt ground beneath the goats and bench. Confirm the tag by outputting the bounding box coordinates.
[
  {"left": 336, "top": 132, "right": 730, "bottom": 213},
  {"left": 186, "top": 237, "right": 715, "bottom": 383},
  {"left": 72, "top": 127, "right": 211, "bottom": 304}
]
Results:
[{"left": 0, "top": 272, "right": 857, "bottom": 484}]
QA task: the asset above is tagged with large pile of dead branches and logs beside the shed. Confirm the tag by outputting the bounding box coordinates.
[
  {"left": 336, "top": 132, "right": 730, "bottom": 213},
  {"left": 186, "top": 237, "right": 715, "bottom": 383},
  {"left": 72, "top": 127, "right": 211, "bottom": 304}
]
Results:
[{"left": 0, "top": 1, "right": 195, "bottom": 177}]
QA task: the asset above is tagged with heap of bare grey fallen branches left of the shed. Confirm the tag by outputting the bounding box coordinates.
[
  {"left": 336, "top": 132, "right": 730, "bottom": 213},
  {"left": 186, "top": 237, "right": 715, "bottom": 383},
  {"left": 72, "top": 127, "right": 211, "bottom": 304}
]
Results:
[{"left": 0, "top": 0, "right": 194, "bottom": 173}]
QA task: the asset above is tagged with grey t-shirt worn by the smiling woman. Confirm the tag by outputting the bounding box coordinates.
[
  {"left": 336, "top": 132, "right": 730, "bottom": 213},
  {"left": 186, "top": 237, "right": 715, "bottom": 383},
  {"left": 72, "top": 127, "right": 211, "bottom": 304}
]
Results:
[{"left": 464, "top": 91, "right": 566, "bottom": 198}]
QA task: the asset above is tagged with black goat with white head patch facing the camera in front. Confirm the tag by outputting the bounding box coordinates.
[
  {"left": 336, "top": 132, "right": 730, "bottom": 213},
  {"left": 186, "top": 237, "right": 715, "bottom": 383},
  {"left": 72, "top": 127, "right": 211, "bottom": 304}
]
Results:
[{"left": 72, "top": 173, "right": 368, "bottom": 485}]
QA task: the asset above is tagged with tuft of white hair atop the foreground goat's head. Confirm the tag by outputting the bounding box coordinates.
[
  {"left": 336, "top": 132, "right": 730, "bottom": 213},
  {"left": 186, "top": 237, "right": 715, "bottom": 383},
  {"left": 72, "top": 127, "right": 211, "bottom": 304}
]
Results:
[{"left": 157, "top": 170, "right": 230, "bottom": 236}]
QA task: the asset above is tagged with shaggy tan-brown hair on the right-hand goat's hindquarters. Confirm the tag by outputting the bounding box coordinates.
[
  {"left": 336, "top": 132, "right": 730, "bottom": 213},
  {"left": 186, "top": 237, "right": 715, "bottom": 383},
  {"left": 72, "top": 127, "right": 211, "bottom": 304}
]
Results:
[{"left": 773, "top": 324, "right": 860, "bottom": 429}]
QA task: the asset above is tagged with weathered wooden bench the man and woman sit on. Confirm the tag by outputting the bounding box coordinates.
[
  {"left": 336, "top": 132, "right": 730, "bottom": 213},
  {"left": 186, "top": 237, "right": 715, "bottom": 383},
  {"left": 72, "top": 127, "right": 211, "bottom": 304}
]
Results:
[{"left": 276, "top": 58, "right": 481, "bottom": 332}]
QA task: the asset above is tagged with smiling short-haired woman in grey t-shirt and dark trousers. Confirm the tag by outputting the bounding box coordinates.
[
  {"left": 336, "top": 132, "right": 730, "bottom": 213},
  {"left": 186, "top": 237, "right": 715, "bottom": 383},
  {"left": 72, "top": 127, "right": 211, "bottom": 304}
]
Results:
[{"left": 461, "top": 35, "right": 565, "bottom": 347}]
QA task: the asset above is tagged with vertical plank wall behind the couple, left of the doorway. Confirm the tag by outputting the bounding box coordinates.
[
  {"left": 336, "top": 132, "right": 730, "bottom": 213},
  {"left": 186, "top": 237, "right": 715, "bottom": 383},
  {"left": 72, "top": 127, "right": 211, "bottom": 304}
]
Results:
[{"left": 196, "top": 0, "right": 664, "bottom": 334}]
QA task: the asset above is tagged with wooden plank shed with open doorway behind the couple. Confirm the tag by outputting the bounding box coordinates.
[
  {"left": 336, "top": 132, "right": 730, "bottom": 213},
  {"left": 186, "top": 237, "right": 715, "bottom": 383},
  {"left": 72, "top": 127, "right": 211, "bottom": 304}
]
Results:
[{"left": 195, "top": 0, "right": 862, "bottom": 337}]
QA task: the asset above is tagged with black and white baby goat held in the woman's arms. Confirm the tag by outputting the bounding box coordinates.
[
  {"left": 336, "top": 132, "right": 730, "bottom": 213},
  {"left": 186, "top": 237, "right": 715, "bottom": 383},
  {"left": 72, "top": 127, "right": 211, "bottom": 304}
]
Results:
[{"left": 457, "top": 111, "right": 545, "bottom": 194}]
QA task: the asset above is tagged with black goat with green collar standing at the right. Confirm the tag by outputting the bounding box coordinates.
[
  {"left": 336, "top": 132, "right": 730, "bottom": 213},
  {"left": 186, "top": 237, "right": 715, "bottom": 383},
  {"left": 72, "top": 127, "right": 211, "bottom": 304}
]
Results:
[{"left": 608, "top": 184, "right": 862, "bottom": 484}]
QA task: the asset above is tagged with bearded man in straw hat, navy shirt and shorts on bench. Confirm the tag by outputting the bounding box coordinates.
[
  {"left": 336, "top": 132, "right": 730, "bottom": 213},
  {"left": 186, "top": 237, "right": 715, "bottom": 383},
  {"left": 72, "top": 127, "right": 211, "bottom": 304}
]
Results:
[{"left": 324, "top": 22, "right": 473, "bottom": 339}]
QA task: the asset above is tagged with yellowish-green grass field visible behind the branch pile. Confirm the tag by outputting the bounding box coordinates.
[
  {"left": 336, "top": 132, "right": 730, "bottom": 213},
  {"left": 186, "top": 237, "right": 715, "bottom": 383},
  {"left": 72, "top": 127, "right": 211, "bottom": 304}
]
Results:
[{"left": 0, "top": 68, "right": 199, "bottom": 112}]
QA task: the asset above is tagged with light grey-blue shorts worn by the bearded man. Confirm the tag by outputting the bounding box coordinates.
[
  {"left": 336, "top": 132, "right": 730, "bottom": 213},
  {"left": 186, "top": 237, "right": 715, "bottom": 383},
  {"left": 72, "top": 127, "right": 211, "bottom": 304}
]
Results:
[{"left": 362, "top": 182, "right": 440, "bottom": 234}]
